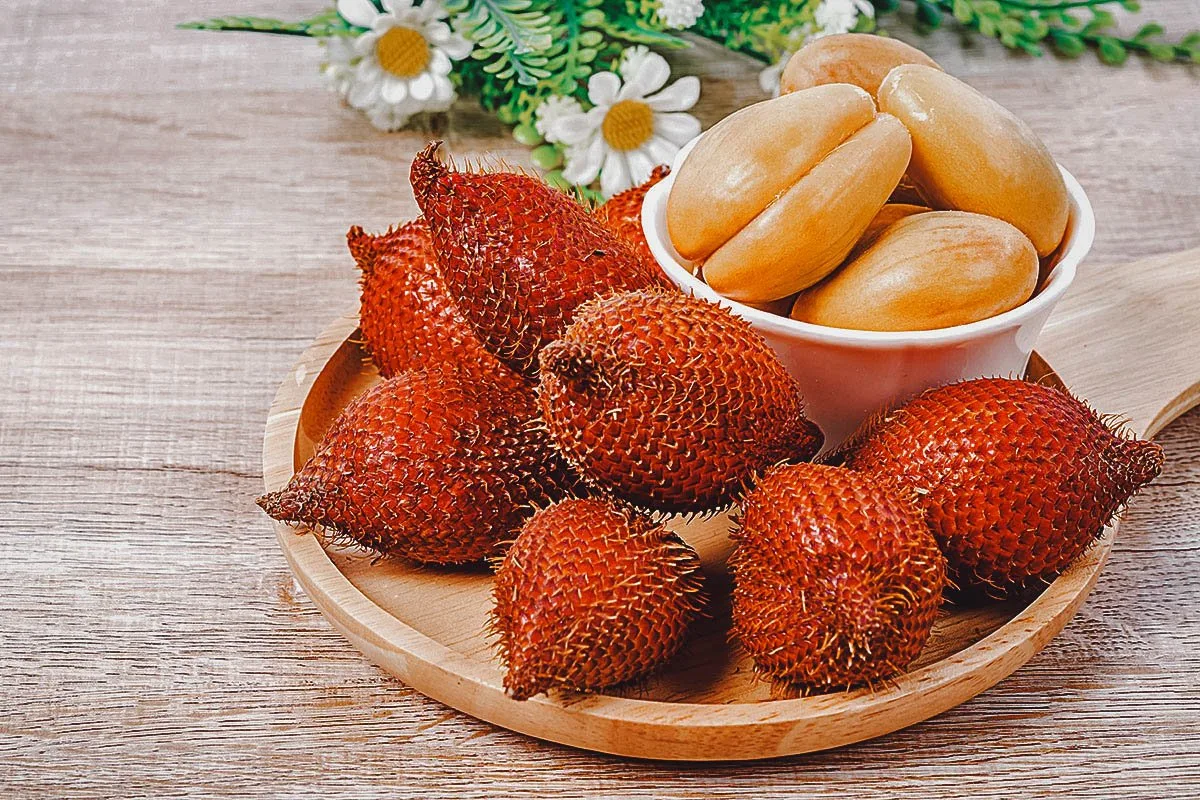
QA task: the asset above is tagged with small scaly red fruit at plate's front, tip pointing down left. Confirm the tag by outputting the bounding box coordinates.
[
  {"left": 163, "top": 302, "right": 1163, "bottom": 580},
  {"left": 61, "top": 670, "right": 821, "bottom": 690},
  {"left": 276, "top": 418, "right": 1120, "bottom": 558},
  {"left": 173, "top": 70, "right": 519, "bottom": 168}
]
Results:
[{"left": 492, "top": 499, "right": 703, "bottom": 700}]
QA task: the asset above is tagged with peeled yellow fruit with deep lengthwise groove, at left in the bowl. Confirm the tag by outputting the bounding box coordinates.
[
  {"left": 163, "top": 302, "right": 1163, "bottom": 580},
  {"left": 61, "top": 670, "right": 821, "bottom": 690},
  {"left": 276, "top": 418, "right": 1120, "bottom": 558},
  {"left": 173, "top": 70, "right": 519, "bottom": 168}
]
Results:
[{"left": 666, "top": 84, "right": 911, "bottom": 303}]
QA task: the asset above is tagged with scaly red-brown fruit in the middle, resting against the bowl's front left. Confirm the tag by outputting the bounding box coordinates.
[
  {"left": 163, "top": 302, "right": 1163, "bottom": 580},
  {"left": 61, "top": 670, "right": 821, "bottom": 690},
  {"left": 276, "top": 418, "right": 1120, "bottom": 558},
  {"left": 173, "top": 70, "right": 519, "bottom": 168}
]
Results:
[{"left": 538, "top": 291, "right": 822, "bottom": 512}]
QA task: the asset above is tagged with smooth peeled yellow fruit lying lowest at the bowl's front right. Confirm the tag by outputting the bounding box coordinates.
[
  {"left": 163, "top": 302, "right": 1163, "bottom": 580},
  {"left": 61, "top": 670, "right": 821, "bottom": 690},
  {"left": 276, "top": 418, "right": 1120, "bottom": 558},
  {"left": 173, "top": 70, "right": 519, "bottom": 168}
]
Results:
[{"left": 792, "top": 211, "right": 1038, "bottom": 331}]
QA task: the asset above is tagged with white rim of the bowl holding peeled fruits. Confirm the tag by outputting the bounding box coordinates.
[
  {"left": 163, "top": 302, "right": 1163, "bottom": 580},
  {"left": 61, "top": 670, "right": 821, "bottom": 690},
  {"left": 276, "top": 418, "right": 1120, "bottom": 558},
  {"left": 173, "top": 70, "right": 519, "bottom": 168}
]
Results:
[{"left": 642, "top": 143, "right": 1096, "bottom": 349}]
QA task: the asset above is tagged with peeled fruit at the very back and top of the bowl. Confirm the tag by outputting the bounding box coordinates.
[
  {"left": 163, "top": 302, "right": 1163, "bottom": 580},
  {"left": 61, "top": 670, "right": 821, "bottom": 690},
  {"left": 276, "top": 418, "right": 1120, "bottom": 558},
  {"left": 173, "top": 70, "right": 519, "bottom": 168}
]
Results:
[{"left": 779, "top": 34, "right": 941, "bottom": 96}]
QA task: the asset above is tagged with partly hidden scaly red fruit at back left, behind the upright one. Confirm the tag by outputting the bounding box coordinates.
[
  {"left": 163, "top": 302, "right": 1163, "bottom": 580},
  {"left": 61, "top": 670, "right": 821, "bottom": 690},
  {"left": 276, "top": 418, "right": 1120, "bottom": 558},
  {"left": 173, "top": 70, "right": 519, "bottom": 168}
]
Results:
[{"left": 346, "top": 217, "right": 505, "bottom": 378}]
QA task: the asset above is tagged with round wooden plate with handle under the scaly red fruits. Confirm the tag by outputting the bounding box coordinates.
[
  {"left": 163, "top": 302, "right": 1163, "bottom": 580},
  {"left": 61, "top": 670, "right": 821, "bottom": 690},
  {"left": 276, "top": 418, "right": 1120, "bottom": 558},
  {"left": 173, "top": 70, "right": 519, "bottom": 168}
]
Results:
[{"left": 264, "top": 247, "right": 1200, "bottom": 760}]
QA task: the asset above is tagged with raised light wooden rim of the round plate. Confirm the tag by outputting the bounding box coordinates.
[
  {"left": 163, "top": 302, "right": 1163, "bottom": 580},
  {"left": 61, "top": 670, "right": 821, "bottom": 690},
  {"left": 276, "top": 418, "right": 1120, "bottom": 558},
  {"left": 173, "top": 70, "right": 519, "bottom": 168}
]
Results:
[{"left": 263, "top": 315, "right": 1123, "bottom": 760}]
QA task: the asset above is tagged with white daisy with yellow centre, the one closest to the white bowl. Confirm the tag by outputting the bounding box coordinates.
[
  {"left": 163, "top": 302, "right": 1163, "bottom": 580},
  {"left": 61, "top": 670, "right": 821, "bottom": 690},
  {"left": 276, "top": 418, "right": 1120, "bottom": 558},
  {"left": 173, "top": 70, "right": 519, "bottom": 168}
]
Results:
[{"left": 550, "top": 50, "right": 700, "bottom": 197}]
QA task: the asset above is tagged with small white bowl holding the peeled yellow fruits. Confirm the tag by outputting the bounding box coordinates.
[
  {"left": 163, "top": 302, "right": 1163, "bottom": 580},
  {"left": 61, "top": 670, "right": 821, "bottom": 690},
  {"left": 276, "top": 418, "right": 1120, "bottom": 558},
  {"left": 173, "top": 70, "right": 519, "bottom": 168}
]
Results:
[{"left": 642, "top": 142, "right": 1096, "bottom": 449}]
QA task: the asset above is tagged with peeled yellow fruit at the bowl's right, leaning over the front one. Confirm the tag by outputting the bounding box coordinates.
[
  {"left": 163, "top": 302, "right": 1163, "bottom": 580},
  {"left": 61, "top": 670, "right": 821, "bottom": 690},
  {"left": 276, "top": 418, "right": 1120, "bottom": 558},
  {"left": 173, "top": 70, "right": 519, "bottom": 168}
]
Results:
[{"left": 878, "top": 64, "right": 1069, "bottom": 255}]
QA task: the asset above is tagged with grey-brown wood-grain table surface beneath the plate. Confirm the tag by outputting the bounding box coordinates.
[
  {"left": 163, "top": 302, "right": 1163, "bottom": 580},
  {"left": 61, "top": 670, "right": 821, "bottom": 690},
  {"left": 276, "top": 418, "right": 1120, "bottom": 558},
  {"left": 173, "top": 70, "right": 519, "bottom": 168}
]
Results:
[{"left": 0, "top": 0, "right": 1200, "bottom": 798}]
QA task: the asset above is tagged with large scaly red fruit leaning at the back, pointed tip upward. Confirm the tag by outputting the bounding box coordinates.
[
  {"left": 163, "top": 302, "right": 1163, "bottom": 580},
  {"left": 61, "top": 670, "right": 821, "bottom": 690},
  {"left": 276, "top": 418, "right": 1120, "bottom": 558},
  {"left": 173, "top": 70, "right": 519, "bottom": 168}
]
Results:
[{"left": 412, "top": 143, "right": 666, "bottom": 375}]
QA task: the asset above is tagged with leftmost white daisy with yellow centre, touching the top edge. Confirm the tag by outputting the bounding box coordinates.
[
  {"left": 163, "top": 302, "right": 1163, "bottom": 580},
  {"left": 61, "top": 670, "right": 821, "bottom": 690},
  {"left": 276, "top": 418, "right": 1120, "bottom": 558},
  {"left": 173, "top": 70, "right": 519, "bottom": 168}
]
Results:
[{"left": 337, "top": 0, "right": 470, "bottom": 130}]
